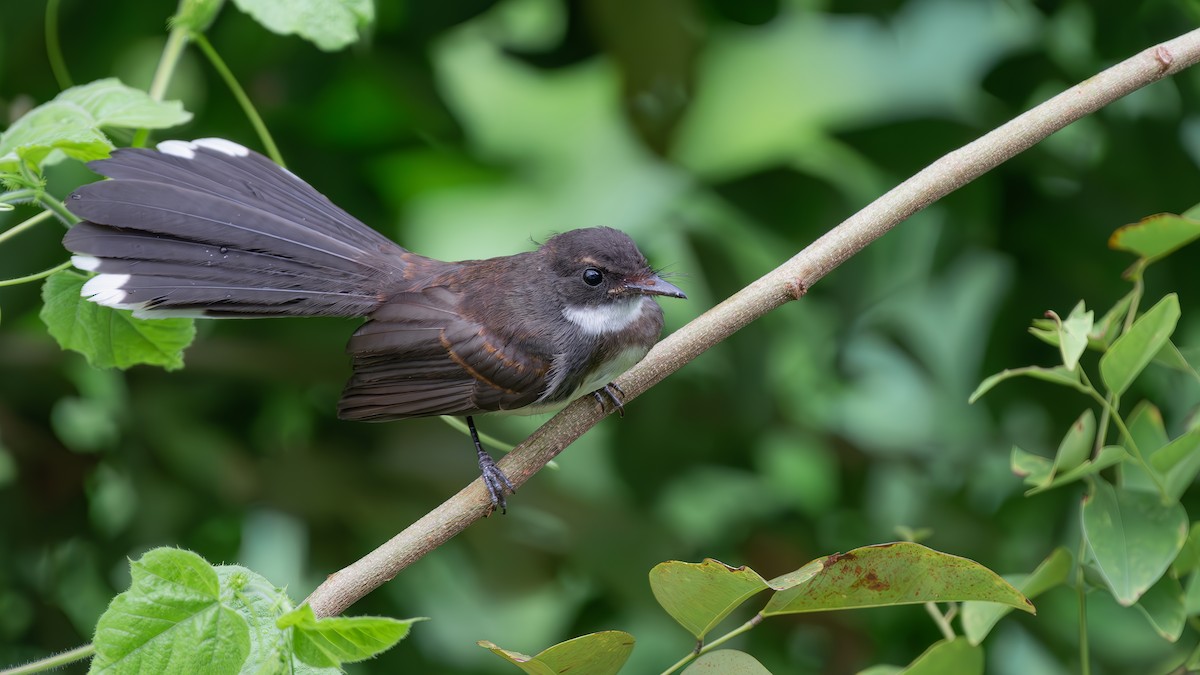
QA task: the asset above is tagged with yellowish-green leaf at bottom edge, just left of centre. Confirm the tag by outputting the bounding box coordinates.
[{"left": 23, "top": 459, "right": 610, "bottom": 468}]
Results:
[{"left": 478, "top": 631, "right": 634, "bottom": 675}]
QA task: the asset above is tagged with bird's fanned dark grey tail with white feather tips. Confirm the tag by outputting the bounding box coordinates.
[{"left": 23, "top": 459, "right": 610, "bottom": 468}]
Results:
[{"left": 62, "top": 138, "right": 412, "bottom": 317}]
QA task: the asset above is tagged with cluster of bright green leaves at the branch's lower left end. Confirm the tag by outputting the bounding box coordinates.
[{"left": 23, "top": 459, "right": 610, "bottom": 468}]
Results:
[{"left": 89, "top": 549, "right": 418, "bottom": 674}]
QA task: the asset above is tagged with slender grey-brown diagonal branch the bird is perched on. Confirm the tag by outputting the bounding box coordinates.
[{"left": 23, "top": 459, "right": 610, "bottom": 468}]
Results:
[{"left": 306, "top": 29, "right": 1200, "bottom": 616}]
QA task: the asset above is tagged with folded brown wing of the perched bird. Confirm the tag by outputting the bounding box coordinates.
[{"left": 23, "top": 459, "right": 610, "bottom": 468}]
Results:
[{"left": 338, "top": 286, "right": 551, "bottom": 422}]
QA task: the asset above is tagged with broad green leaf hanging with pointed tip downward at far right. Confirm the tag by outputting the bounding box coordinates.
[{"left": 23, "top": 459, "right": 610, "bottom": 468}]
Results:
[{"left": 1081, "top": 478, "right": 1188, "bottom": 607}]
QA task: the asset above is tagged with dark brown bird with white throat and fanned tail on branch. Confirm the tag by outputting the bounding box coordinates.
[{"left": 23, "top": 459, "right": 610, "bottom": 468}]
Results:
[{"left": 62, "top": 138, "right": 686, "bottom": 512}]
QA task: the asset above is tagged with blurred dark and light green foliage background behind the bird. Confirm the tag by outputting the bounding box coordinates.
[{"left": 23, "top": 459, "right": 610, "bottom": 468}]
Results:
[{"left": 0, "top": 0, "right": 1200, "bottom": 675}]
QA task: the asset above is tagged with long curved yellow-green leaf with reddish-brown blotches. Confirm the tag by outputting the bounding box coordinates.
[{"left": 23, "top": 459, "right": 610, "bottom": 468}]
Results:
[{"left": 762, "top": 542, "right": 1033, "bottom": 616}]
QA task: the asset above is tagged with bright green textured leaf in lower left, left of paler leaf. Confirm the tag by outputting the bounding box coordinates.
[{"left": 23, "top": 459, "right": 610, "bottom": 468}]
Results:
[{"left": 89, "top": 549, "right": 250, "bottom": 673}]
